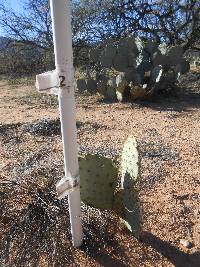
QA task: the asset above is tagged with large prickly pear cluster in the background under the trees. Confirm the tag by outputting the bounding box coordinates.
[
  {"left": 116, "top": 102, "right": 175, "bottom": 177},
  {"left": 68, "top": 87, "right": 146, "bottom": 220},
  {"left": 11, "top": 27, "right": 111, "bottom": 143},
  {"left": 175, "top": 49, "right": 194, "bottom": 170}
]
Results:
[{"left": 77, "top": 37, "right": 190, "bottom": 101}]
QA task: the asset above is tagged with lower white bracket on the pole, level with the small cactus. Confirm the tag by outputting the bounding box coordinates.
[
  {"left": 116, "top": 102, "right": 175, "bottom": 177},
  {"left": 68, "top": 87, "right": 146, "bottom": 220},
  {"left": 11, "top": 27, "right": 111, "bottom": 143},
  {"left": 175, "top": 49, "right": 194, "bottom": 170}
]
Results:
[{"left": 56, "top": 175, "right": 80, "bottom": 199}]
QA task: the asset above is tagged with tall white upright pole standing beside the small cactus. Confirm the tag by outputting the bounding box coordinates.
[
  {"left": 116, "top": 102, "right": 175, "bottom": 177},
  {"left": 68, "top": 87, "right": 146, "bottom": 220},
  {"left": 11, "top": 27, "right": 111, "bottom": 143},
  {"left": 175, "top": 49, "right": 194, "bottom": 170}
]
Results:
[{"left": 50, "top": 0, "right": 82, "bottom": 246}]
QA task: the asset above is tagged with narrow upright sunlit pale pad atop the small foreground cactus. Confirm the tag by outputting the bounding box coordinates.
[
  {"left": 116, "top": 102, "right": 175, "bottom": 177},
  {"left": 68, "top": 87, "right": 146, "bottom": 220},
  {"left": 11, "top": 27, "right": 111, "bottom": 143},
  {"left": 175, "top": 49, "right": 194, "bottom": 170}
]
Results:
[{"left": 121, "top": 136, "right": 139, "bottom": 189}]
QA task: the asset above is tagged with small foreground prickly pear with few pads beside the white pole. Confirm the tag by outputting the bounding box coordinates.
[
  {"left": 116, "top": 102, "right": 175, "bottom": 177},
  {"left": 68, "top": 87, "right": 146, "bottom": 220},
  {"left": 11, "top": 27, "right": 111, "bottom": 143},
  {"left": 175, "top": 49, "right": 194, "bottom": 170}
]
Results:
[{"left": 79, "top": 136, "right": 142, "bottom": 236}]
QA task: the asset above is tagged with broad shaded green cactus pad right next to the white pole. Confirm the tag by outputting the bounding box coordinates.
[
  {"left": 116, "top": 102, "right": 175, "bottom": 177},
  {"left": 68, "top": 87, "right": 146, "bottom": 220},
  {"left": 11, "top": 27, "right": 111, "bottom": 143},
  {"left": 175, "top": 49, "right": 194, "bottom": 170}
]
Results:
[{"left": 79, "top": 155, "right": 118, "bottom": 210}]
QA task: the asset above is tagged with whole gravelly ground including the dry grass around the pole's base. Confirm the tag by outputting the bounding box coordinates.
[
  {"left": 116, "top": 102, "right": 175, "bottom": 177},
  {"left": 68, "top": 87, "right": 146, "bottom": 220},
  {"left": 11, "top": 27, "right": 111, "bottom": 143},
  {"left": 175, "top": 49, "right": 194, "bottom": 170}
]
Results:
[{"left": 0, "top": 73, "right": 200, "bottom": 267}]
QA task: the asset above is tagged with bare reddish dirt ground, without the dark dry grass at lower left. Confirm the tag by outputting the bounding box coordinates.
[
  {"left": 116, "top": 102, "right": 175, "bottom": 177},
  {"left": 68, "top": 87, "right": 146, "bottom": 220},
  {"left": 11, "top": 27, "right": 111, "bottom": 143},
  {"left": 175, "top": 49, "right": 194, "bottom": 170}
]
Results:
[{"left": 0, "top": 73, "right": 200, "bottom": 267}]
